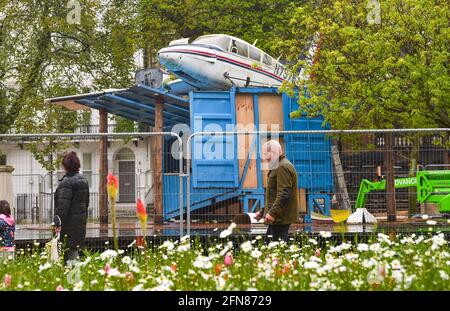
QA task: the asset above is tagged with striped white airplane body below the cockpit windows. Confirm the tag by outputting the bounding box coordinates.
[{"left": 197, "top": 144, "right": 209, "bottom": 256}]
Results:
[{"left": 158, "top": 37, "right": 289, "bottom": 90}]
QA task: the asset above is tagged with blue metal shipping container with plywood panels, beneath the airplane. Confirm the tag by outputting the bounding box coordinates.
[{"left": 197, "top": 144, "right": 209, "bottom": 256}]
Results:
[{"left": 164, "top": 88, "right": 334, "bottom": 218}]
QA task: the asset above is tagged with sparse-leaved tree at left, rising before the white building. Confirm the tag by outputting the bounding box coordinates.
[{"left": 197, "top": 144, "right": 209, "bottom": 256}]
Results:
[{"left": 0, "top": 0, "right": 136, "bottom": 171}]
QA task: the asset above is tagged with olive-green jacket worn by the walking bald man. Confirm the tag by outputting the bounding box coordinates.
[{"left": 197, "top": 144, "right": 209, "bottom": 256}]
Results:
[{"left": 264, "top": 155, "right": 299, "bottom": 225}]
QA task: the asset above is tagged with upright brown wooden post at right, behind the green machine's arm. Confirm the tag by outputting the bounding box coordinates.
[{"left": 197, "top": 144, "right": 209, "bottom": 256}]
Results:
[{"left": 384, "top": 133, "right": 397, "bottom": 221}]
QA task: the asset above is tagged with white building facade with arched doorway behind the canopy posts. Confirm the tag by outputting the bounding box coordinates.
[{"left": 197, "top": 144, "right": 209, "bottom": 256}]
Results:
[{"left": 0, "top": 110, "right": 153, "bottom": 223}]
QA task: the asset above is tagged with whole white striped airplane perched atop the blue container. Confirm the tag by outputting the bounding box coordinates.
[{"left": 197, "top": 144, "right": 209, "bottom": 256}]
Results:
[{"left": 157, "top": 34, "right": 294, "bottom": 94}]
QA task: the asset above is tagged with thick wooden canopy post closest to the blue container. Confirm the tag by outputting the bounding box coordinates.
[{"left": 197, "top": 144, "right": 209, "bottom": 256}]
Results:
[{"left": 152, "top": 96, "right": 164, "bottom": 224}]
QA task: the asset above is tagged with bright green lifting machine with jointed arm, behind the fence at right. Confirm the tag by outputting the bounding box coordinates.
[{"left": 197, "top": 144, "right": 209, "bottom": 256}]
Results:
[{"left": 347, "top": 165, "right": 450, "bottom": 223}]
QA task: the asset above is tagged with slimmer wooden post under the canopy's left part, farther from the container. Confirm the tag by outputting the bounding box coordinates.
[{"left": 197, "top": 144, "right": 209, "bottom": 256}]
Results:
[{"left": 98, "top": 109, "right": 108, "bottom": 226}]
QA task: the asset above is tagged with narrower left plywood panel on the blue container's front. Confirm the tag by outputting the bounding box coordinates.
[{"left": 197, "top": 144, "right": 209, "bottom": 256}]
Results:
[{"left": 236, "top": 94, "right": 258, "bottom": 189}]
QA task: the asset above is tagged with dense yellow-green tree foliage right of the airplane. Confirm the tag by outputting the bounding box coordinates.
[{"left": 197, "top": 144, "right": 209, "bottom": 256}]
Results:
[{"left": 285, "top": 0, "right": 450, "bottom": 129}]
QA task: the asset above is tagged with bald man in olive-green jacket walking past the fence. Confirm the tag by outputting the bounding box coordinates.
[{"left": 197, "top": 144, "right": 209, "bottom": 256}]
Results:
[{"left": 255, "top": 140, "right": 298, "bottom": 241}]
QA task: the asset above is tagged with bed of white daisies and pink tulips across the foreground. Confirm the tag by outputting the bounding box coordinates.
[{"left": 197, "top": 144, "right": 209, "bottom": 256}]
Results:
[{"left": 0, "top": 233, "right": 450, "bottom": 291}]
